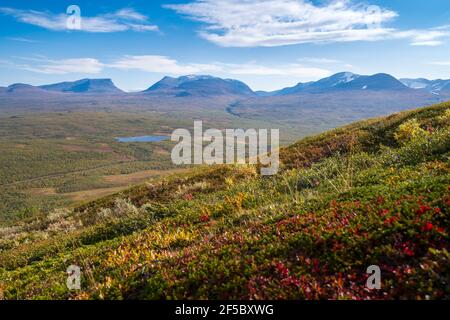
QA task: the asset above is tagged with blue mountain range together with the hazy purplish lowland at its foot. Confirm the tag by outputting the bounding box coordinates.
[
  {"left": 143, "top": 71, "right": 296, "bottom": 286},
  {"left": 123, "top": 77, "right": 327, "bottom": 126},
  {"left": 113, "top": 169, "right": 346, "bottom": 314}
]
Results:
[{"left": 0, "top": 72, "right": 450, "bottom": 128}]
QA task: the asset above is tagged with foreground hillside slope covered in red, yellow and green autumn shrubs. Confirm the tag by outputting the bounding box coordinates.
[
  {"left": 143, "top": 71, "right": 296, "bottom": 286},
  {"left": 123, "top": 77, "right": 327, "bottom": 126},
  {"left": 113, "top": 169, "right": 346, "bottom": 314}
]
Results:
[{"left": 0, "top": 103, "right": 450, "bottom": 299}]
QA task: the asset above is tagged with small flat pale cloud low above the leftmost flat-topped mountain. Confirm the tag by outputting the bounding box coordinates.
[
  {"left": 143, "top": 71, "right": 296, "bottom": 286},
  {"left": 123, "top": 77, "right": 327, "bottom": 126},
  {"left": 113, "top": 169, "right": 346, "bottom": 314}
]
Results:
[{"left": 12, "top": 58, "right": 103, "bottom": 74}]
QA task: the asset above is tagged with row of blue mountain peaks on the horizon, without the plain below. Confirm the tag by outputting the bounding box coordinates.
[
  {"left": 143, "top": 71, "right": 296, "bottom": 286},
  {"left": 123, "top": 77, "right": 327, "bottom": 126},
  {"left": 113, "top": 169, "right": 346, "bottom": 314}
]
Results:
[{"left": 0, "top": 72, "right": 450, "bottom": 97}]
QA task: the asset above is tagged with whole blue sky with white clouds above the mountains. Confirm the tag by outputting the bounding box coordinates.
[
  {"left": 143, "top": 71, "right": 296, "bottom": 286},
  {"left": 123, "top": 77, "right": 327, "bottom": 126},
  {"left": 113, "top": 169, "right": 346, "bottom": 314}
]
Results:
[{"left": 0, "top": 0, "right": 450, "bottom": 91}]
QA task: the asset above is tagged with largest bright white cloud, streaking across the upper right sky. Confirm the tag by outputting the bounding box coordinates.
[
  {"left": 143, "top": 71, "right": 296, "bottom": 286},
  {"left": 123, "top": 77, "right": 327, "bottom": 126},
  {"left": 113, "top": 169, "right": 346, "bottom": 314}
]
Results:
[{"left": 165, "top": 0, "right": 450, "bottom": 47}]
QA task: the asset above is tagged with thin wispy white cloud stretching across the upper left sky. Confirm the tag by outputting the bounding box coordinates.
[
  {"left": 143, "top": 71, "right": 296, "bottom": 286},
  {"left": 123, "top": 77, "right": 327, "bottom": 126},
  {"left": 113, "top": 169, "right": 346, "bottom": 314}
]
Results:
[{"left": 0, "top": 7, "right": 158, "bottom": 32}]
